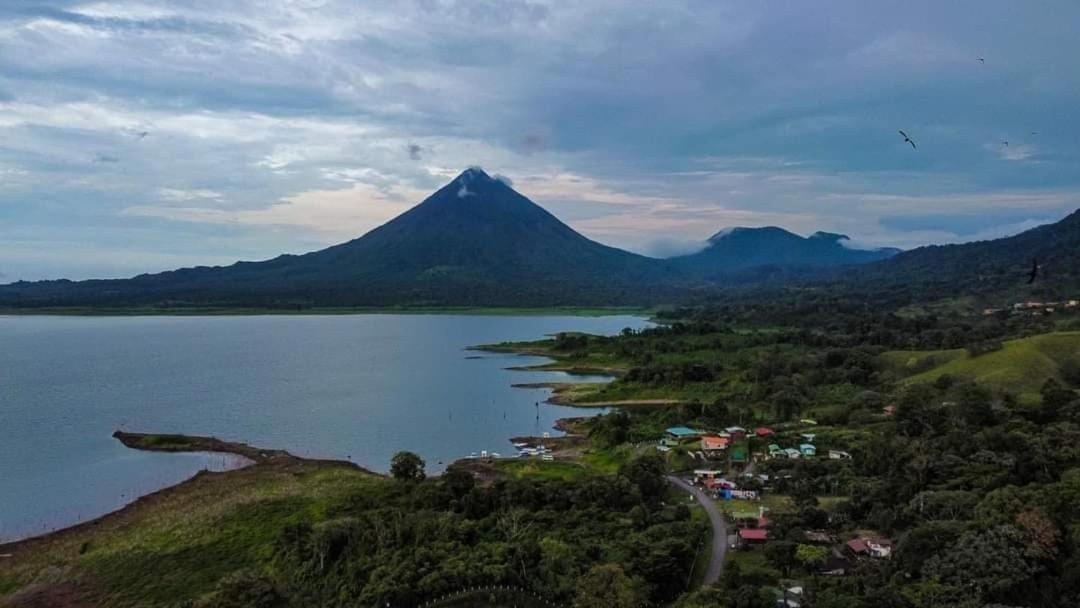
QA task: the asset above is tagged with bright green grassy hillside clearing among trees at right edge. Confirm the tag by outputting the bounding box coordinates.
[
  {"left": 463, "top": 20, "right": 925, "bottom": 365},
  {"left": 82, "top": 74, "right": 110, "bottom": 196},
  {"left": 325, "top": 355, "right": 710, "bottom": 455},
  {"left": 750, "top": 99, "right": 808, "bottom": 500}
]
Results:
[{"left": 882, "top": 332, "right": 1080, "bottom": 401}]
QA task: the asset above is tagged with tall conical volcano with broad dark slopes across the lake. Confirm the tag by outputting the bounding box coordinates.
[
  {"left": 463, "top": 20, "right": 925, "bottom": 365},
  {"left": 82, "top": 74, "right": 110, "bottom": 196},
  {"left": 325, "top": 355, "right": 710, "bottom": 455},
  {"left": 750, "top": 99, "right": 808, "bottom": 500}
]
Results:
[{"left": 0, "top": 168, "right": 673, "bottom": 307}]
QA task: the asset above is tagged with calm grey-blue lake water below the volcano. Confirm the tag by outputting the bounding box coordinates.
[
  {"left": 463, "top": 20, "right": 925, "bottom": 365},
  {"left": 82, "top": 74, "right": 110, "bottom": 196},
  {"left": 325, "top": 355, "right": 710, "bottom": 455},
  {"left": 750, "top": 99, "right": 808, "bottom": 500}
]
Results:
[{"left": 0, "top": 314, "right": 647, "bottom": 541}]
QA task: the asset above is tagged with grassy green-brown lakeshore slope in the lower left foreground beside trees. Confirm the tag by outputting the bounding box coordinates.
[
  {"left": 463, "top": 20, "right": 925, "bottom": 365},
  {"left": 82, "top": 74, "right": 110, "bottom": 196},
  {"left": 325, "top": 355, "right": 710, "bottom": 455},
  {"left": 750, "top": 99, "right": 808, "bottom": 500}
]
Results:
[{"left": 0, "top": 459, "right": 378, "bottom": 607}]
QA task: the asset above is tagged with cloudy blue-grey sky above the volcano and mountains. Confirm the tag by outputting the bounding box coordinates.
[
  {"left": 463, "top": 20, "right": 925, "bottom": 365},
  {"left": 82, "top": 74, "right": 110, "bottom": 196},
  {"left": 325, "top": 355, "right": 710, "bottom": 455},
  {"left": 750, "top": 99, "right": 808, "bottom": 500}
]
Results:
[{"left": 0, "top": 0, "right": 1080, "bottom": 283}]
